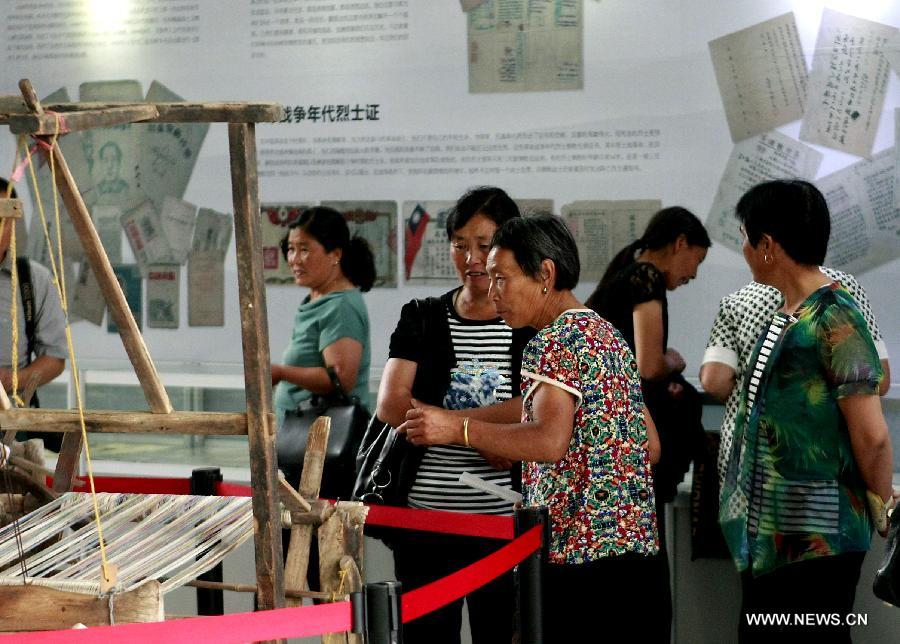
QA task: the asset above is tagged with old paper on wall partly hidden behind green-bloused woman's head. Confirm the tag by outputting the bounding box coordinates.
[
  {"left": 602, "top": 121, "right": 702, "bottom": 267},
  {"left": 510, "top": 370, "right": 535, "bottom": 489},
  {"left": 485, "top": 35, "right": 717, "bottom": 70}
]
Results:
[{"left": 706, "top": 130, "right": 822, "bottom": 252}]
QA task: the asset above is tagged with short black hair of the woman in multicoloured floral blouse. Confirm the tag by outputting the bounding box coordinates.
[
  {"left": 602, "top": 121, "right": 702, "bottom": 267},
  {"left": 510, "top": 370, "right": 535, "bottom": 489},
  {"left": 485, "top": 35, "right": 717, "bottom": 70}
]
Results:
[{"left": 491, "top": 214, "right": 581, "bottom": 291}]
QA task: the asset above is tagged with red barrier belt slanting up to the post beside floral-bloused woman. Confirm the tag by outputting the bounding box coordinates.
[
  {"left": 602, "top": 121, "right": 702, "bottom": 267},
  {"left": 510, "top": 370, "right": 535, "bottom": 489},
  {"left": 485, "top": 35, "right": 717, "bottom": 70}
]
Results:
[{"left": 400, "top": 526, "right": 542, "bottom": 624}]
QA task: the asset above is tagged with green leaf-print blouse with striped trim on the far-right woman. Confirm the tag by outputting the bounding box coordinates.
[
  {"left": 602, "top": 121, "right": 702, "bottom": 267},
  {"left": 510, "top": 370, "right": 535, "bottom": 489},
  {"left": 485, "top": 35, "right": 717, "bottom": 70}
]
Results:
[{"left": 719, "top": 282, "right": 883, "bottom": 575}]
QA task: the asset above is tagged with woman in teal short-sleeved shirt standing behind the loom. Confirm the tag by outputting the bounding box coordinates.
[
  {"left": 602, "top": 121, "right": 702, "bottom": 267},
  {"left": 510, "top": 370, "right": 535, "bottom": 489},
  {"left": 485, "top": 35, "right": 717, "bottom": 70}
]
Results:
[{"left": 272, "top": 206, "right": 375, "bottom": 496}]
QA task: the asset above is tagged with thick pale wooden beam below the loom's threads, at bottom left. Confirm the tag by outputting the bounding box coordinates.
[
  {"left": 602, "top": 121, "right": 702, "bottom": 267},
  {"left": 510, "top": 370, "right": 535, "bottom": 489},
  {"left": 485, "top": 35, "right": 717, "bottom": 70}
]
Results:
[{"left": 0, "top": 580, "right": 164, "bottom": 632}]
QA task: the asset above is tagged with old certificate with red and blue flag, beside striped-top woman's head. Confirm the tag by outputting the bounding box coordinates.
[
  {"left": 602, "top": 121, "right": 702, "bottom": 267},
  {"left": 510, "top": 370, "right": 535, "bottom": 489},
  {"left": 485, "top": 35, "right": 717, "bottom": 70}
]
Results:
[{"left": 403, "top": 201, "right": 457, "bottom": 284}]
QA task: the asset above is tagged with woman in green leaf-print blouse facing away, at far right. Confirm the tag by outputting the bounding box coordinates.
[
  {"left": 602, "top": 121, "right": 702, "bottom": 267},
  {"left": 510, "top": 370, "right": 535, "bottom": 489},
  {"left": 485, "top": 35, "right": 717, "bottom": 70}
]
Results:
[{"left": 719, "top": 180, "right": 893, "bottom": 642}]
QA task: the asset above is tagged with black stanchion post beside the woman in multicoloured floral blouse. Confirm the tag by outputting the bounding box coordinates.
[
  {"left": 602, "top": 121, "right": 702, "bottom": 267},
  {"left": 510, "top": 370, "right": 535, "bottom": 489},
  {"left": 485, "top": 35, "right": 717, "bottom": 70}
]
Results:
[{"left": 515, "top": 507, "right": 550, "bottom": 644}]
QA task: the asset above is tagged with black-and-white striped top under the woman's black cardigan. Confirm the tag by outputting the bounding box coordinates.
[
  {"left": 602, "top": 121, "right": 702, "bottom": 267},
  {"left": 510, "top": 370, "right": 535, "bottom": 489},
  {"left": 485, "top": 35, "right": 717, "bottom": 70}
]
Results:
[{"left": 408, "top": 307, "right": 518, "bottom": 514}]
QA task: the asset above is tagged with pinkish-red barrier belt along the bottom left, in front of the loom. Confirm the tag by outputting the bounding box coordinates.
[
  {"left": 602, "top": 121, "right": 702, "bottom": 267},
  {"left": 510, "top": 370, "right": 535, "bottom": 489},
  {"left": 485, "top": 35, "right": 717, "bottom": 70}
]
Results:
[{"left": 0, "top": 602, "right": 352, "bottom": 644}]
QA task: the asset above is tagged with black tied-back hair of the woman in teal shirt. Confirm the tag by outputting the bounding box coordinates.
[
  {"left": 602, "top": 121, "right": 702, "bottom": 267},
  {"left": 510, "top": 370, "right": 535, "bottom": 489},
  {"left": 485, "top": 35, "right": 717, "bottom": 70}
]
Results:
[{"left": 281, "top": 206, "right": 375, "bottom": 293}]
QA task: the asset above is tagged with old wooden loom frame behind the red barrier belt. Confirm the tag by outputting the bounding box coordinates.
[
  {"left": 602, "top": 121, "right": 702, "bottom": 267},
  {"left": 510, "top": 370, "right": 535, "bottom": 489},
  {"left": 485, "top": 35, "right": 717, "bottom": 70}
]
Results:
[{"left": 0, "top": 80, "right": 365, "bottom": 630}]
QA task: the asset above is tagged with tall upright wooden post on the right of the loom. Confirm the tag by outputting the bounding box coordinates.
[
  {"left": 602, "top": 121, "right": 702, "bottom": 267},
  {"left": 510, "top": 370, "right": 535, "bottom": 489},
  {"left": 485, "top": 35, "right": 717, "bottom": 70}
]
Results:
[{"left": 228, "top": 123, "right": 284, "bottom": 610}]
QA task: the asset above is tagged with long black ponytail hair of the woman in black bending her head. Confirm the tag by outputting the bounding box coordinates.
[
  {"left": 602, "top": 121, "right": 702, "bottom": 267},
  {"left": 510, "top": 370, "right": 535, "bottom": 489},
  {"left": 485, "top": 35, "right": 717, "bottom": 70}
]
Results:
[{"left": 587, "top": 206, "right": 712, "bottom": 308}]
